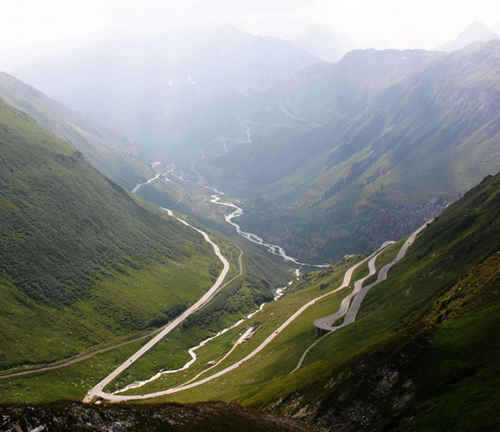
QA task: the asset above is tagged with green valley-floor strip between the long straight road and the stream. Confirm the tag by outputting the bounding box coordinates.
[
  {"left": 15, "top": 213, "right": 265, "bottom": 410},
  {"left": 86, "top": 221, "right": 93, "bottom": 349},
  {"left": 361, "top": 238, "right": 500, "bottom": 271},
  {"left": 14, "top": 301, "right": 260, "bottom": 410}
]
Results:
[{"left": 104, "top": 238, "right": 293, "bottom": 391}]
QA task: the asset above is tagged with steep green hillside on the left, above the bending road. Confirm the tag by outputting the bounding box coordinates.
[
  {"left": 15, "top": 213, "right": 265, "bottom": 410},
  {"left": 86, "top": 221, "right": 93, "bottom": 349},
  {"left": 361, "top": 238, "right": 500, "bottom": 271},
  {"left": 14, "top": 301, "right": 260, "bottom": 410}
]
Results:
[{"left": 0, "top": 98, "right": 220, "bottom": 368}]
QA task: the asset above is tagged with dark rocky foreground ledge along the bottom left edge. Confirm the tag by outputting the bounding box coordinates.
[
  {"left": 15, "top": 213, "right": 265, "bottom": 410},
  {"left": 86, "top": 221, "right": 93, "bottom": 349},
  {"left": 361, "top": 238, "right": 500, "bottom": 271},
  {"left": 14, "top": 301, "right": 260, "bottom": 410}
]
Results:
[{"left": 0, "top": 402, "right": 311, "bottom": 432}]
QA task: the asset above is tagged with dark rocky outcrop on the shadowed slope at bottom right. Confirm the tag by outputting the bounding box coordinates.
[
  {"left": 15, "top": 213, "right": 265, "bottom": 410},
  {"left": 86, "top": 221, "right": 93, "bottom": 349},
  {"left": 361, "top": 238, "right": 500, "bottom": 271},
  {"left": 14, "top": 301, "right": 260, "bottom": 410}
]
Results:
[{"left": 265, "top": 336, "right": 426, "bottom": 432}]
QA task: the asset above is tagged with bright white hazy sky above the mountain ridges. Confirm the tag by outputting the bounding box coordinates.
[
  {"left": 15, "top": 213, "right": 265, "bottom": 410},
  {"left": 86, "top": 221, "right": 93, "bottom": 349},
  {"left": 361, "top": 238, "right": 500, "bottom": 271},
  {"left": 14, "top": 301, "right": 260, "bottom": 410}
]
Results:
[{"left": 0, "top": 0, "right": 500, "bottom": 70}]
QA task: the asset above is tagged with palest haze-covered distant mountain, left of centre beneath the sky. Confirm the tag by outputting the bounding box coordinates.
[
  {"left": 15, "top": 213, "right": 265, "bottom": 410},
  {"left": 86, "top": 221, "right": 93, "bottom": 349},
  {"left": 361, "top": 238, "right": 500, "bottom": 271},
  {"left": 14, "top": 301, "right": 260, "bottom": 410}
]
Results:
[{"left": 16, "top": 27, "right": 317, "bottom": 162}]
